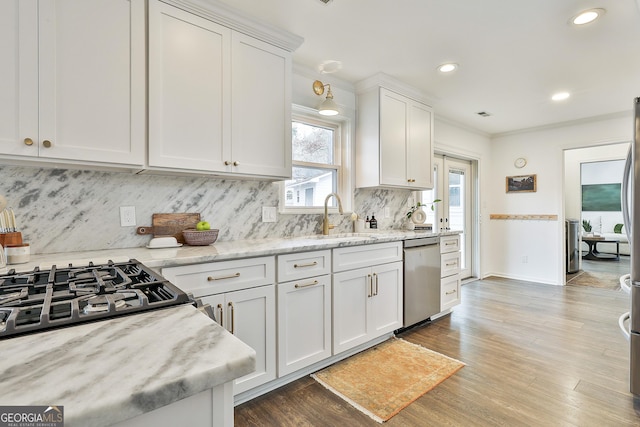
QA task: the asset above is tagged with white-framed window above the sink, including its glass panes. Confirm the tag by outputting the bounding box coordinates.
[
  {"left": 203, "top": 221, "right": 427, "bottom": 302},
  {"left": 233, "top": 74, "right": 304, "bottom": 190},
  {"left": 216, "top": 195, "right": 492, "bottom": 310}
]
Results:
[{"left": 280, "top": 107, "right": 352, "bottom": 213}]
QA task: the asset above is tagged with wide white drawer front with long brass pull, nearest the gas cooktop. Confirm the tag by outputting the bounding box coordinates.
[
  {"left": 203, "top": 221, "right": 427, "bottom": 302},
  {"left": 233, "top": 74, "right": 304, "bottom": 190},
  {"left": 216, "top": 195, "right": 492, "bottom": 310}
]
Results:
[{"left": 162, "top": 257, "right": 276, "bottom": 298}]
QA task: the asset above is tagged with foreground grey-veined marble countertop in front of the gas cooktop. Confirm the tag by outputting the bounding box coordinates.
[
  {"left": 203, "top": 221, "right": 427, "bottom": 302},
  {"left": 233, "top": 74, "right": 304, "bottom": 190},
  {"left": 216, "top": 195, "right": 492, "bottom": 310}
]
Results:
[{"left": 0, "top": 305, "right": 256, "bottom": 427}]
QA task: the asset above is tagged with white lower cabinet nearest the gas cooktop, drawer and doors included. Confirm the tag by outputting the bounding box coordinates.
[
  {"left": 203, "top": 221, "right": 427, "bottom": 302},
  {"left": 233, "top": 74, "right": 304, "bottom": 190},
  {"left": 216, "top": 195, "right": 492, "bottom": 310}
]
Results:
[{"left": 162, "top": 257, "right": 276, "bottom": 395}]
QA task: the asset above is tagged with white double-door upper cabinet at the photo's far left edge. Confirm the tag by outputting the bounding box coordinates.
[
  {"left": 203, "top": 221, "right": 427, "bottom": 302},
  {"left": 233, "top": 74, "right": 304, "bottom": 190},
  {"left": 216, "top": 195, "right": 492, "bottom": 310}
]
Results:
[{"left": 0, "top": 0, "right": 146, "bottom": 167}]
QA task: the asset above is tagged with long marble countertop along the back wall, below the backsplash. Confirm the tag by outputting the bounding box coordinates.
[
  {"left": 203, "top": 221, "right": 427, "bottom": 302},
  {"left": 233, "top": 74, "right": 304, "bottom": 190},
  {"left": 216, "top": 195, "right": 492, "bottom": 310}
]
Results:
[{"left": 7, "top": 230, "right": 459, "bottom": 271}]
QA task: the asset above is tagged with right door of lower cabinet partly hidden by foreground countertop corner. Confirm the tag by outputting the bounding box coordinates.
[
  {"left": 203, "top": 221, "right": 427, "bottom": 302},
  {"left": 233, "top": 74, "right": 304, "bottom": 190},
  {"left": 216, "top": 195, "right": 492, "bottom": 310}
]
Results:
[{"left": 225, "top": 285, "right": 276, "bottom": 395}]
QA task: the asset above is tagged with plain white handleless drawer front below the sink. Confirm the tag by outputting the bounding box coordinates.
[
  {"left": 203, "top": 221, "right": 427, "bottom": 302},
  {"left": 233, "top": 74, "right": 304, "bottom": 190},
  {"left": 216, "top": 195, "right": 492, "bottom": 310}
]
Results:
[{"left": 333, "top": 242, "right": 402, "bottom": 273}]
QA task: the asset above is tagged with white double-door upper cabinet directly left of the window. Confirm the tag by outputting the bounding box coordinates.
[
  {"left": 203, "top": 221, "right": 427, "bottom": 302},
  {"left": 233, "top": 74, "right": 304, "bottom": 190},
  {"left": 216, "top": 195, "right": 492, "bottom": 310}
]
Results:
[{"left": 149, "top": 1, "right": 292, "bottom": 179}]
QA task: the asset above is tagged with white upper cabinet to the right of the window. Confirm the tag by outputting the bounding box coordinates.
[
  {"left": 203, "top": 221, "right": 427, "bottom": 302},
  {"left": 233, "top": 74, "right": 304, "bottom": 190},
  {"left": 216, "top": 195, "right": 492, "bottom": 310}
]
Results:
[{"left": 356, "top": 76, "right": 433, "bottom": 190}]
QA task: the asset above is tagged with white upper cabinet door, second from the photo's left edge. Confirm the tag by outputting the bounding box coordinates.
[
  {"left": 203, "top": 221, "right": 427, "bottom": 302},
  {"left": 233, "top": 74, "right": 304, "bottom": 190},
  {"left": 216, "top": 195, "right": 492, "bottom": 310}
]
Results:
[{"left": 37, "top": 0, "right": 146, "bottom": 165}]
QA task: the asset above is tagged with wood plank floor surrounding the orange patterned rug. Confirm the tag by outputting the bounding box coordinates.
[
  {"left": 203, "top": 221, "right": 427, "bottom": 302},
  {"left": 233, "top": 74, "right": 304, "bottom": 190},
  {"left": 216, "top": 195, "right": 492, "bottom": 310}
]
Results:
[{"left": 235, "top": 276, "right": 640, "bottom": 427}]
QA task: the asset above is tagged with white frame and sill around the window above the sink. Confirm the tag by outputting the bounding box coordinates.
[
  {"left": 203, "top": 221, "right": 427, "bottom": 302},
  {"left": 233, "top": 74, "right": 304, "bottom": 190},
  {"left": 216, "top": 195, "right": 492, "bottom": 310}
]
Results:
[{"left": 278, "top": 104, "right": 354, "bottom": 215}]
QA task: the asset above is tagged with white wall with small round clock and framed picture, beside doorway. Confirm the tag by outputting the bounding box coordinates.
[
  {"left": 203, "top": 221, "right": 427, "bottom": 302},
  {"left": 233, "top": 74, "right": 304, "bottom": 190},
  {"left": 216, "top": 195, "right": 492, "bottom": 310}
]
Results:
[{"left": 485, "top": 113, "right": 633, "bottom": 285}]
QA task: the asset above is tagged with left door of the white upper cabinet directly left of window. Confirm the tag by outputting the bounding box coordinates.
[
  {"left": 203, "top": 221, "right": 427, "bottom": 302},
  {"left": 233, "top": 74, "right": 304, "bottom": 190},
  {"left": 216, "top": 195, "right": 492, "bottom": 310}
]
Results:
[{"left": 149, "top": 1, "right": 231, "bottom": 171}]
